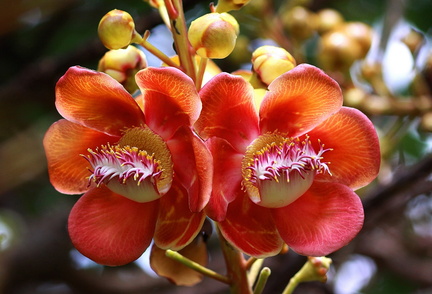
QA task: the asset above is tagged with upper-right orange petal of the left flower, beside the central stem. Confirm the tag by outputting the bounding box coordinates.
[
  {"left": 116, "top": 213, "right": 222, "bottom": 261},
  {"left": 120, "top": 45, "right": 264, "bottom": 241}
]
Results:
[{"left": 135, "top": 67, "right": 202, "bottom": 140}]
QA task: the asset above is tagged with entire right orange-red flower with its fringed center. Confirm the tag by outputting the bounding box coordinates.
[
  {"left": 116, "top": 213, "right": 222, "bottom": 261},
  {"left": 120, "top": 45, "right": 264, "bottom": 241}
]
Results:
[{"left": 195, "top": 64, "right": 380, "bottom": 257}]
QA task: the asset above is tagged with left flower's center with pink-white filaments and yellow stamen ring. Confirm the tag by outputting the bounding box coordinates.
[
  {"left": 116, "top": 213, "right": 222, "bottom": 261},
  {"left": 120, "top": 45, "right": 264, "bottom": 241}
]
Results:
[{"left": 83, "top": 128, "right": 173, "bottom": 202}]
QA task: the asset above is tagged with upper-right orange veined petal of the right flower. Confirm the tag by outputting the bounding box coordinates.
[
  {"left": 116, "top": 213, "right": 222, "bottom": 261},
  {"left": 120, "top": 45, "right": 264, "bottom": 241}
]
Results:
[{"left": 260, "top": 64, "right": 343, "bottom": 137}]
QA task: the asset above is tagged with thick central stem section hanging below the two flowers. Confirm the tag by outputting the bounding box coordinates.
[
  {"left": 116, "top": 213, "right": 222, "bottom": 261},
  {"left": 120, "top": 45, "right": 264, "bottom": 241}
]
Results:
[{"left": 218, "top": 228, "right": 252, "bottom": 294}]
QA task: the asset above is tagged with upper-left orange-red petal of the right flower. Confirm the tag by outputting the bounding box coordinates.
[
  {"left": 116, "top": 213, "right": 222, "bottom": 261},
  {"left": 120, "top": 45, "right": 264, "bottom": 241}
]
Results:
[{"left": 195, "top": 73, "right": 259, "bottom": 152}]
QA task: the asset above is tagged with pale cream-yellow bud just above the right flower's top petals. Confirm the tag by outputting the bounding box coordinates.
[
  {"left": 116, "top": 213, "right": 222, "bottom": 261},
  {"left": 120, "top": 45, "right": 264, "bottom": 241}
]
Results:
[{"left": 252, "top": 45, "right": 296, "bottom": 85}]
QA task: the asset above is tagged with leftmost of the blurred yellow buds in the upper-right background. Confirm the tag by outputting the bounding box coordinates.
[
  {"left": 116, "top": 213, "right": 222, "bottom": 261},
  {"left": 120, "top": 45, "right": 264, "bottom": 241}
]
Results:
[{"left": 282, "top": 6, "right": 317, "bottom": 41}]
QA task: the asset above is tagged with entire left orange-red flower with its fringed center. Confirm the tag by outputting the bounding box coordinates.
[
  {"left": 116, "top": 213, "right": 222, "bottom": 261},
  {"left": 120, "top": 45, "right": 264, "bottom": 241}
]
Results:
[{"left": 44, "top": 67, "right": 212, "bottom": 265}]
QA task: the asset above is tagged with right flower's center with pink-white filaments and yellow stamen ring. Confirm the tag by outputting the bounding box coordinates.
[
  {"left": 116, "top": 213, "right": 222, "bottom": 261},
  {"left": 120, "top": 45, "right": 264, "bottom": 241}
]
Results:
[{"left": 242, "top": 134, "right": 332, "bottom": 208}]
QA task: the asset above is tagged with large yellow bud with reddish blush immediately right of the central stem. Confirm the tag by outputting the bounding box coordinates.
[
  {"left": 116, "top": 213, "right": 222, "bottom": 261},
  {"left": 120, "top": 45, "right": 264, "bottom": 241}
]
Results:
[{"left": 188, "top": 12, "right": 239, "bottom": 59}]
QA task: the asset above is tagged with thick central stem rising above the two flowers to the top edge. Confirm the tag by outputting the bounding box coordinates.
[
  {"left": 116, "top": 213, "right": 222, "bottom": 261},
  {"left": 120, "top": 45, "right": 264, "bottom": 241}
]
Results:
[{"left": 165, "top": 0, "right": 196, "bottom": 81}]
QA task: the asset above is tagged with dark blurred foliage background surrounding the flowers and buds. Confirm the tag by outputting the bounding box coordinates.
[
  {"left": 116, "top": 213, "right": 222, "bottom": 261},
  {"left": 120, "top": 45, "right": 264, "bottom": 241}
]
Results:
[{"left": 0, "top": 0, "right": 432, "bottom": 294}]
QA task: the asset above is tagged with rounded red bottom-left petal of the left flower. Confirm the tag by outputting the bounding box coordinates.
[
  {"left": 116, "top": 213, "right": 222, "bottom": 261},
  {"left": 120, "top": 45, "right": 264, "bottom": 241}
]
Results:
[{"left": 68, "top": 186, "right": 159, "bottom": 266}]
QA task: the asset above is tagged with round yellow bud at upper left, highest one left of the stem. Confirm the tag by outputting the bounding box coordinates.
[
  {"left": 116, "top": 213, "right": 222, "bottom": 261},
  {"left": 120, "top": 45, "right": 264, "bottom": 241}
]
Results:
[{"left": 98, "top": 9, "right": 140, "bottom": 49}]
